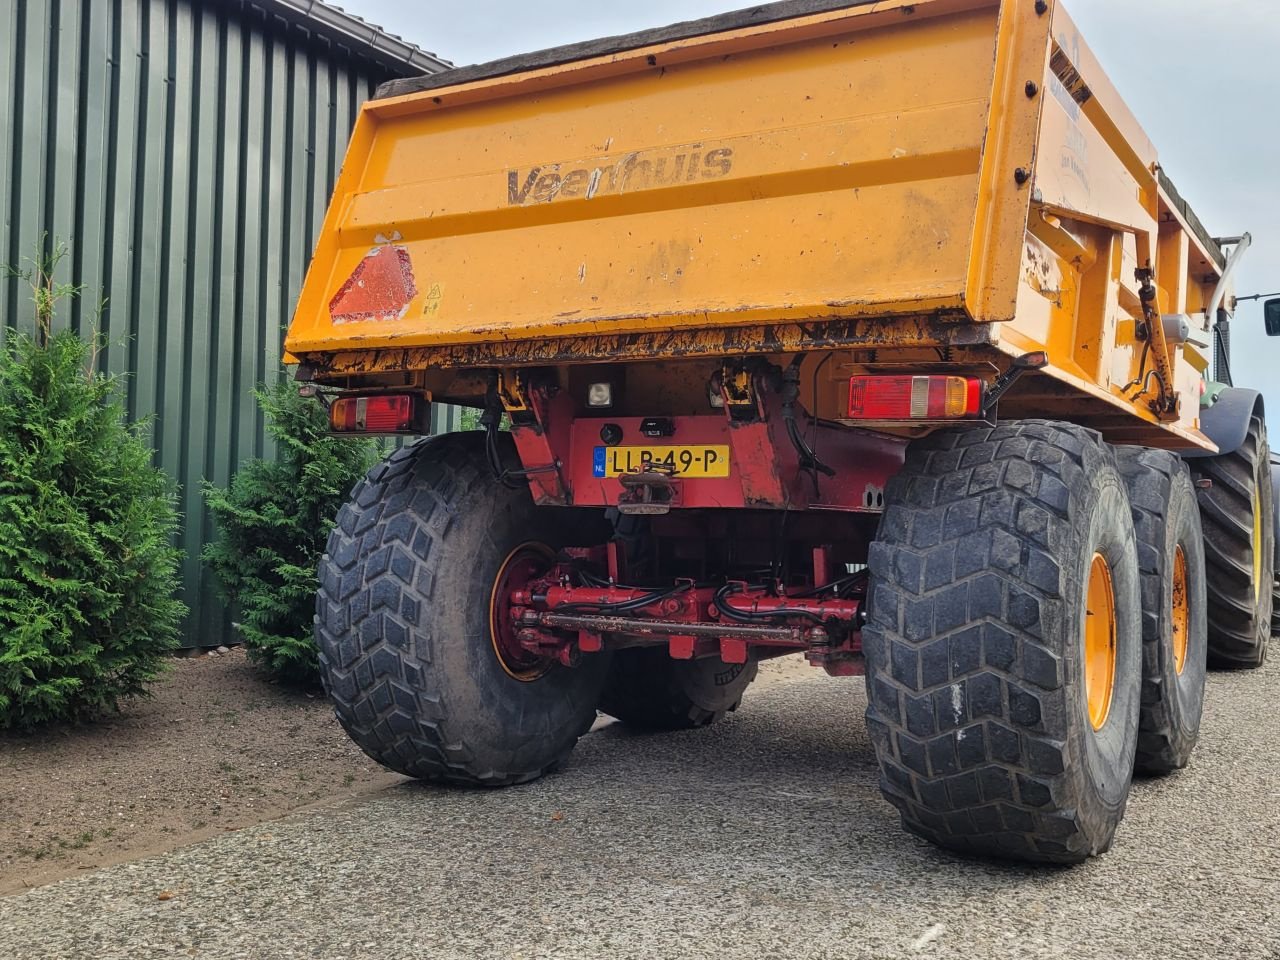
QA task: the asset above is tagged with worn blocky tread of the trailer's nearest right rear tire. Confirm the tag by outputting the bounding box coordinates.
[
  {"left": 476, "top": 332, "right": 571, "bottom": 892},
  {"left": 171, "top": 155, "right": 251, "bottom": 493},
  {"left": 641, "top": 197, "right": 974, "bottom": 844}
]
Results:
[{"left": 863, "top": 420, "right": 1123, "bottom": 863}]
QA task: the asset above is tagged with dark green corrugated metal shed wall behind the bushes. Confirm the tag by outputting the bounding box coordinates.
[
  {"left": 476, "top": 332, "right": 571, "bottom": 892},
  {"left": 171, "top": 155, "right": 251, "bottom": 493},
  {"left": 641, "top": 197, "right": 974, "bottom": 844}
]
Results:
[{"left": 0, "top": 0, "right": 450, "bottom": 646}]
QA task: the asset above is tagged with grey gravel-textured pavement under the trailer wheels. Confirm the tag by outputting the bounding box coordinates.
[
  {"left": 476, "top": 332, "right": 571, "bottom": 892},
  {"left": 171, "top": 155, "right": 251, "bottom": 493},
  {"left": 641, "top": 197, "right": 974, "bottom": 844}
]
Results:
[{"left": 0, "top": 664, "right": 1280, "bottom": 960}]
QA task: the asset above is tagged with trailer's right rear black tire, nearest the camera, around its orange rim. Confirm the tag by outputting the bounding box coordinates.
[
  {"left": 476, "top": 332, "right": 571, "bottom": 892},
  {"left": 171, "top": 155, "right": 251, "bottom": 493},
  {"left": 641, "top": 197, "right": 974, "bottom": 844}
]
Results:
[{"left": 863, "top": 421, "right": 1142, "bottom": 863}]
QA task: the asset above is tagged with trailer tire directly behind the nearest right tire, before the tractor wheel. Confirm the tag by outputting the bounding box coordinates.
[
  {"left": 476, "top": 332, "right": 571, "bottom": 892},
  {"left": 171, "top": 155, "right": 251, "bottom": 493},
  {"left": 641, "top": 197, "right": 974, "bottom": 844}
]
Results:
[{"left": 1116, "top": 447, "right": 1208, "bottom": 773}]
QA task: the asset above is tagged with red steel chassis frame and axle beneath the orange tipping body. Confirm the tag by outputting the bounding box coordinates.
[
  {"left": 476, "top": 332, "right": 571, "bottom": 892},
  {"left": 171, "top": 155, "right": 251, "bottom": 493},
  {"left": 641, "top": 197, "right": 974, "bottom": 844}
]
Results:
[{"left": 490, "top": 383, "right": 908, "bottom": 676}]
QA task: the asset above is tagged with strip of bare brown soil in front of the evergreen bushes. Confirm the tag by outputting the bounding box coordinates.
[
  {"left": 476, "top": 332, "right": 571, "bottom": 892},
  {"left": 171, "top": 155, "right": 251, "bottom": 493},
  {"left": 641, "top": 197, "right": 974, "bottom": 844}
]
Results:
[{"left": 0, "top": 650, "right": 402, "bottom": 895}]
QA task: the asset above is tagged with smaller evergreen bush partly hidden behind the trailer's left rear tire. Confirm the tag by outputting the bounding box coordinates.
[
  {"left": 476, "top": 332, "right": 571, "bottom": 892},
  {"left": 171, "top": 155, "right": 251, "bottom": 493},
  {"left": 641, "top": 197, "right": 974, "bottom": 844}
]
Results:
[{"left": 205, "top": 378, "right": 379, "bottom": 684}]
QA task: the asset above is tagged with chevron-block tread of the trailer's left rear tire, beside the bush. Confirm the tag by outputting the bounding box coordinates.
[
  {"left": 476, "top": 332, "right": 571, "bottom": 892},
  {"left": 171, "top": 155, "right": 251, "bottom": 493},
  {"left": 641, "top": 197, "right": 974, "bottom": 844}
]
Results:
[{"left": 315, "top": 433, "right": 594, "bottom": 787}]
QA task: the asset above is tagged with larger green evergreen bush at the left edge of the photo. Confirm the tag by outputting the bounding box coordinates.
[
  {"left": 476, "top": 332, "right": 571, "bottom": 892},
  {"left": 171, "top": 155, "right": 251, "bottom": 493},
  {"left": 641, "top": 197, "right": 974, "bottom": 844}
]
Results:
[{"left": 0, "top": 246, "right": 186, "bottom": 728}]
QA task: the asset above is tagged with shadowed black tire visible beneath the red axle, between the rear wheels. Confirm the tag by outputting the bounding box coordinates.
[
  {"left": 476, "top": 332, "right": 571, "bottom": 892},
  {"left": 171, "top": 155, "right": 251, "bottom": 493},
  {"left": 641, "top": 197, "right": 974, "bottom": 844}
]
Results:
[{"left": 600, "top": 646, "right": 759, "bottom": 730}]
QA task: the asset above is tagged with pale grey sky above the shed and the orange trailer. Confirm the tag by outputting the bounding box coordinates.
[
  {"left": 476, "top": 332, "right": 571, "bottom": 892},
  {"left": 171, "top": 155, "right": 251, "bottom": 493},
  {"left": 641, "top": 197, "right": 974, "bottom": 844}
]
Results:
[{"left": 340, "top": 0, "right": 1280, "bottom": 409}]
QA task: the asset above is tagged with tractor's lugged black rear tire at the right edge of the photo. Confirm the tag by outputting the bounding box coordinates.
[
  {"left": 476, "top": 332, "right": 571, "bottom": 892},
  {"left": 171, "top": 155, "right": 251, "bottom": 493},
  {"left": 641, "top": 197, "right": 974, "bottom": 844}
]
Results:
[{"left": 1193, "top": 416, "right": 1276, "bottom": 669}]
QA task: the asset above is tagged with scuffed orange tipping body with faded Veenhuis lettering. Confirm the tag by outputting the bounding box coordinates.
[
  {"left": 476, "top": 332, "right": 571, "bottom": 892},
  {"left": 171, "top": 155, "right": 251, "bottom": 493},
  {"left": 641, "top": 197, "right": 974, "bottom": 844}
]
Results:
[{"left": 285, "top": 0, "right": 1225, "bottom": 448}]
